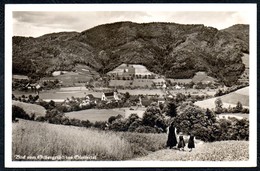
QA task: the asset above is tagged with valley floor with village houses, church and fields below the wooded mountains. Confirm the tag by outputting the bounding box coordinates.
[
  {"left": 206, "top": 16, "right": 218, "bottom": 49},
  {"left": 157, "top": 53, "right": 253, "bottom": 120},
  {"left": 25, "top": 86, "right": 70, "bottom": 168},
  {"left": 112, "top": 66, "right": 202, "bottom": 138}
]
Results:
[{"left": 13, "top": 61, "right": 250, "bottom": 123}]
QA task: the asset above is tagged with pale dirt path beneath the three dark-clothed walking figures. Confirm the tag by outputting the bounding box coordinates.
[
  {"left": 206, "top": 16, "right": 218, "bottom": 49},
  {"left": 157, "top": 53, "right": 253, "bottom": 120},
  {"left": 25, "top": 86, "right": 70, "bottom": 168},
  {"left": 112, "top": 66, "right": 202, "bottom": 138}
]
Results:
[{"left": 133, "top": 142, "right": 204, "bottom": 161}]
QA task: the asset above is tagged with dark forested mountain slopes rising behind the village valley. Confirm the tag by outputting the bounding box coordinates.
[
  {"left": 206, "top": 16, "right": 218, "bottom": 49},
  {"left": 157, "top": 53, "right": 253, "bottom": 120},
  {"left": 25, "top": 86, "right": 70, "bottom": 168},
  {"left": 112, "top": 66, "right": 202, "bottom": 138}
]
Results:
[{"left": 13, "top": 22, "right": 249, "bottom": 85}]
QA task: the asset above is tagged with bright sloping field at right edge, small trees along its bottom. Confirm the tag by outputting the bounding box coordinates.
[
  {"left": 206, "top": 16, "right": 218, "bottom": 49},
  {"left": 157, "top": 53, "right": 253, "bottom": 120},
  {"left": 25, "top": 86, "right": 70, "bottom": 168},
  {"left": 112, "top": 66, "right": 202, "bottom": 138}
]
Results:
[{"left": 195, "top": 87, "right": 249, "bottom": 109}]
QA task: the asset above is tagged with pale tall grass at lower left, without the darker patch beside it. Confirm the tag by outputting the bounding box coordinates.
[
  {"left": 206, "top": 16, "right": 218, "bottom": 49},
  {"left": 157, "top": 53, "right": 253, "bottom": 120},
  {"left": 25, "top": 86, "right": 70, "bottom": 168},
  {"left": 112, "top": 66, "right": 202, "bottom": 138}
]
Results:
[{"left": 12, "top": 120, "right": 133, "bottom": 160}]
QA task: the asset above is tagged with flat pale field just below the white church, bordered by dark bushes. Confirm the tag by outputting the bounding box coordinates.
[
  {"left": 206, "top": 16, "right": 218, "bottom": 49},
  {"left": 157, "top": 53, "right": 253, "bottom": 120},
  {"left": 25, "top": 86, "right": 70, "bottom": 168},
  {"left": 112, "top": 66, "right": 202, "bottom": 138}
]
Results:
[{"left": 65, "top": 109, "right": 125, "bottom": 122}]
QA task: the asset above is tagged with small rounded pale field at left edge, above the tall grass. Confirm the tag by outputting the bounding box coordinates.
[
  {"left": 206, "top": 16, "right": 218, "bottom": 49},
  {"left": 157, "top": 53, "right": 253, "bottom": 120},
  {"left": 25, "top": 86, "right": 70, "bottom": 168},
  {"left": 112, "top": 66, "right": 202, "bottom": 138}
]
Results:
[{"left": 12, "top": 100, "right": 46, "bottom": 117}]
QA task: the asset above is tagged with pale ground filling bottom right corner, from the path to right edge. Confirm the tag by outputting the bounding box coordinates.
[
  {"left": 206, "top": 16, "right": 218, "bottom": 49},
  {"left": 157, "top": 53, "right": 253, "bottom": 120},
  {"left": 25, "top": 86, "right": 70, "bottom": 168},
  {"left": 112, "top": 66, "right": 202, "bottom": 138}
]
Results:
[{"left": 134, "top": 141, "right": 249, "bottom": 161}]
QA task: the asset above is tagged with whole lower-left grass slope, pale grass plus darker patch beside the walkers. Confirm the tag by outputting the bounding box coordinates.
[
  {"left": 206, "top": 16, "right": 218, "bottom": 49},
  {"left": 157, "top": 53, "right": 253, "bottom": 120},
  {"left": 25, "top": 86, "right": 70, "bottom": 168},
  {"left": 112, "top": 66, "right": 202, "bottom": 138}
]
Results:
[{"left": 12, "top": 120, "right": 166, "bottom": 160}]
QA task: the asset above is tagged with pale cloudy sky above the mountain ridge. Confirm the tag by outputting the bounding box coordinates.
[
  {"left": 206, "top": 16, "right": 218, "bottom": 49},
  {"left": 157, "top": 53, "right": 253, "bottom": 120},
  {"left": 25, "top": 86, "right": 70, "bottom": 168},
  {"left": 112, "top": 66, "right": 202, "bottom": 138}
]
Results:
[{"left": 12, "top": 11, "right": 249, "bottom": 37}]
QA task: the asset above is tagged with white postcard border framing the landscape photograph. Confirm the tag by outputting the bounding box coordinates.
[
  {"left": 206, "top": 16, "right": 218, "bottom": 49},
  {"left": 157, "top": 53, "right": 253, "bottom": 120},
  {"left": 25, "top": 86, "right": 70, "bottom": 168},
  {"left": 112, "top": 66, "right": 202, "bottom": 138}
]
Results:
[{"left": 5, "top": 4, "right": 257, "bottom": 168}]
